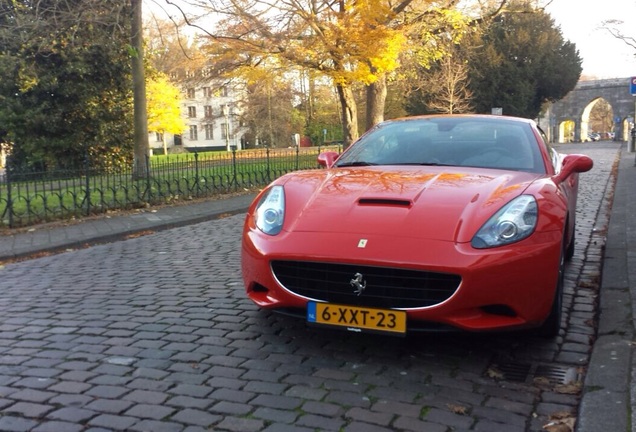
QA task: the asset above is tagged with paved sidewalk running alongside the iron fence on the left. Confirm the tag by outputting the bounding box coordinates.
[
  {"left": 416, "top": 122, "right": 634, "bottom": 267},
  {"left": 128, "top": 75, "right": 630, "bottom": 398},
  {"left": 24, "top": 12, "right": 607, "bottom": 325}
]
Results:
[{"left": 0, "top": 193, "right": 255, "bottom": 262}]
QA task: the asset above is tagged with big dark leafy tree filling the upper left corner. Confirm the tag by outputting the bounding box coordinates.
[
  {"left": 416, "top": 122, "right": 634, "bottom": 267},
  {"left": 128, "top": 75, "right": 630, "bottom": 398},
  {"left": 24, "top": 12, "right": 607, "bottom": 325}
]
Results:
[{"left": 0, "top": 0, "right": 131, "bottom": 169}]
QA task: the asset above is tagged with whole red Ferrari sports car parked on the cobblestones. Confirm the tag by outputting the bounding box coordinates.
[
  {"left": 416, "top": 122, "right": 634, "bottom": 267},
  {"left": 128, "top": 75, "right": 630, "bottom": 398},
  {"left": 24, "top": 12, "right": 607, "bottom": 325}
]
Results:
[{"left": 241, "top": 115, "right": 593, "bottom": 336}]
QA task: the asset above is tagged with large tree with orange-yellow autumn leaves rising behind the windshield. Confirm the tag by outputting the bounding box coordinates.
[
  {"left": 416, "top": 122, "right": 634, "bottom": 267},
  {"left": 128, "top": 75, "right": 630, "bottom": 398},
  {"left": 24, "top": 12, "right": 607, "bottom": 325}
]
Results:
[{"left": 167, "top": 0, "right": 486, "bottom": 144}]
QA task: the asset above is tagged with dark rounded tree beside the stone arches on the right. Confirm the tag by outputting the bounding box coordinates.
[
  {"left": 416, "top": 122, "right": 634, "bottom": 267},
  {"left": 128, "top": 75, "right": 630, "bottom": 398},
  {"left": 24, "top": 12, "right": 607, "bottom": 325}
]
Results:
[{"left": 469, "top": 1, "right": 582, "bottom": 118}]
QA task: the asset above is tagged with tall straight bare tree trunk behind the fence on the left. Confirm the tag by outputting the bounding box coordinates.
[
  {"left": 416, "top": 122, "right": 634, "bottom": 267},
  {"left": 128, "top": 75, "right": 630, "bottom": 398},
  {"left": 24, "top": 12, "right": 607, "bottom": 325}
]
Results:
[{"left": 130, "top": 0, "right": 150, "bottom": 179}]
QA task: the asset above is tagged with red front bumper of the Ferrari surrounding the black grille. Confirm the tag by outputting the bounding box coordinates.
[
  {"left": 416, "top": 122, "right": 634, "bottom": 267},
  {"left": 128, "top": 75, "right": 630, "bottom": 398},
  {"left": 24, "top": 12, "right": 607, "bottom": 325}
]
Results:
[{"left": 241, "top": 228, "right": 562, "bottom": 331}]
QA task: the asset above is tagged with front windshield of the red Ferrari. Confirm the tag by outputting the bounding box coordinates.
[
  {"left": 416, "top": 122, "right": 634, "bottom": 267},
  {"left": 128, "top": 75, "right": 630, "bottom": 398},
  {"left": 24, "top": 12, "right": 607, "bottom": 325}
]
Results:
[{"left": 335, "top": 116, "right": 545, "bottom": 173}]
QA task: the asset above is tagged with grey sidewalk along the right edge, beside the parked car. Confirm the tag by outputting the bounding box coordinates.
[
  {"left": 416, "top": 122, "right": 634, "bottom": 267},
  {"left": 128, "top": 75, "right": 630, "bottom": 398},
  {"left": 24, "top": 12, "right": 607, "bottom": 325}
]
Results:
[{"left": 576, "top": 147, "right": 636, "bottom": 432}]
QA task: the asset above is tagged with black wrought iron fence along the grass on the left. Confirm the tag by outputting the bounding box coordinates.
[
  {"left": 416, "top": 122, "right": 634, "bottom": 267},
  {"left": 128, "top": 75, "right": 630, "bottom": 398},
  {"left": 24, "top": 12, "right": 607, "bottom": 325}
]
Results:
[{"left": 0, "top": 147, "right": 340, "bottom": 228}]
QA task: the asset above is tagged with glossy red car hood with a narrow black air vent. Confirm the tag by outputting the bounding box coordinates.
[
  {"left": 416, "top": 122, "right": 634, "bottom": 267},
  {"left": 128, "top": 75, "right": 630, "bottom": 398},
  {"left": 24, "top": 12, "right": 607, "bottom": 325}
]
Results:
[{"left": 277, "top": 167, "right": 541, "bottom": 242}]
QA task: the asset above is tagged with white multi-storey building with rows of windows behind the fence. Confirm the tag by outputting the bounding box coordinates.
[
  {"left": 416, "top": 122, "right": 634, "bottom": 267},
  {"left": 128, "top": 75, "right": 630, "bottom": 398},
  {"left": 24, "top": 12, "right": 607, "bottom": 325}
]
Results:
[{"left": 149, "top": 76, "right": 246, "bottom": 154}]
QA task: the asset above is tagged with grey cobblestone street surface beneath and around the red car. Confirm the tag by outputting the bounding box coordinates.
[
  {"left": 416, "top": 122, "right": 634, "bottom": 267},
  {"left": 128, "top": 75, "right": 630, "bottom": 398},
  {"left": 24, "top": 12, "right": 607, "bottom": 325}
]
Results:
[{"left": 0, "top": 143, "right": 620, "bottom": 432}]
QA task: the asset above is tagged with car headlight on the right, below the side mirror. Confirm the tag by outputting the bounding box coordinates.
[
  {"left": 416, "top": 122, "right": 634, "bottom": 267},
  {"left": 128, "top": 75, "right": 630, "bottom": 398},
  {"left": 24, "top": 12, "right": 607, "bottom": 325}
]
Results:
[{"left": 470, "top": 195, "right": 537, "bottom": 249}]
